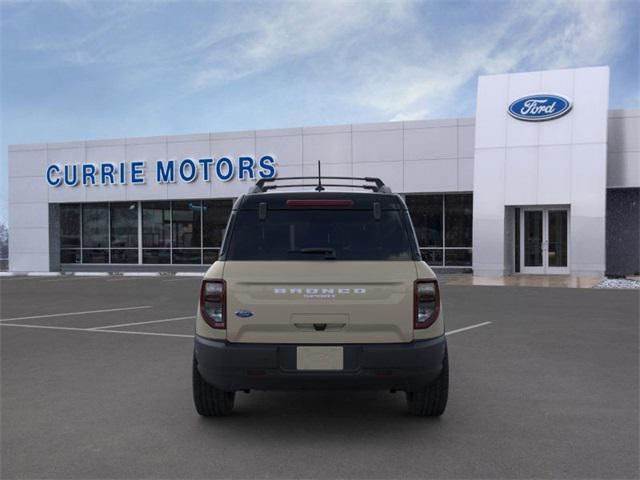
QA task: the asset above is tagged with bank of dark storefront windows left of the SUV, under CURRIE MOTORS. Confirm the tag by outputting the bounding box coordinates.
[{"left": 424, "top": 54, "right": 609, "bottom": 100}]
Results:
[{"left": 60, "top": 199, "right": 238, "bottom": 265}]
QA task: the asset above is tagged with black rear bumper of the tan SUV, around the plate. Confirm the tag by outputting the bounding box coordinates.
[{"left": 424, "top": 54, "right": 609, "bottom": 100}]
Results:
[{"left": 195, "top": 335, "right": 446, "bottom": 391}]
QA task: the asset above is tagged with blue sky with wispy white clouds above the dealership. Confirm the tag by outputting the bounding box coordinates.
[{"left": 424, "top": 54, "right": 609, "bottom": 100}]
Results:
[{"left": 0, "top": 0, "right": 640, "bottom": 226}]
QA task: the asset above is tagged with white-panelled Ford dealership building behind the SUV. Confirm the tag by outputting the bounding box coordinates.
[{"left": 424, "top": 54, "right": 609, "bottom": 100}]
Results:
[{"left": 9, "top": 67, "right": 640, "bottom": 276}]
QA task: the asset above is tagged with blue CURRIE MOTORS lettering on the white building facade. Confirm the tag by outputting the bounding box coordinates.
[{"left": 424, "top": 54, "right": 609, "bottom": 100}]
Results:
[{"left": 45, "top": 155, "right": 277, "bottom": 187}]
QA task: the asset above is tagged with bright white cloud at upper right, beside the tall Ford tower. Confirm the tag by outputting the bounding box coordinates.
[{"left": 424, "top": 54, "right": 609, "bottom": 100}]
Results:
[{"left": 355, "top": 0, "right": 624, "bottom": 120}]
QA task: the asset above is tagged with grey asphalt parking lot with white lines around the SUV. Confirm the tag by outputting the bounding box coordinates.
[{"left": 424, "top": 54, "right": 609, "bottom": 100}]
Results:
[{"left": 0, "top": 277, "right": 640, "bottom": 478}]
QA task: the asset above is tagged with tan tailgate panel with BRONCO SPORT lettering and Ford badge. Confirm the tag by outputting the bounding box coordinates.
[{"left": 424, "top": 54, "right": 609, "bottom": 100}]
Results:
[{"left": 224, "top": 261, "right": 416, "bottom": 343}]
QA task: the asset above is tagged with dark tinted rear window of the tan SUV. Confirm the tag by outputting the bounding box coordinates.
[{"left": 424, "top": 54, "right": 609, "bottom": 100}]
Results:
[{"left": 223, "top": 209, "right": 417, "bottom": 260}]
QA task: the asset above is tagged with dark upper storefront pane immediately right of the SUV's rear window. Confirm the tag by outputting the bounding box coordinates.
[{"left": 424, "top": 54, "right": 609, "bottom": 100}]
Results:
[{"left": 405, "top": 195, "right": 443, "bottom": 248}]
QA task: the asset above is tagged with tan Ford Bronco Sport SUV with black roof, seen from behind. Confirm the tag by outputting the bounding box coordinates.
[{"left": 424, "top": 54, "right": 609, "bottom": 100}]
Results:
[{"left": 193, "top": 177, "right": 449, "bottom": 416}]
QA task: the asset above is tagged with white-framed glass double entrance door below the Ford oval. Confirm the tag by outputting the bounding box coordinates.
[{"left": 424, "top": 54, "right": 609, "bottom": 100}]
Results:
[{"left": 520, "top": 208, "right": 569, "bottom": 274}]
